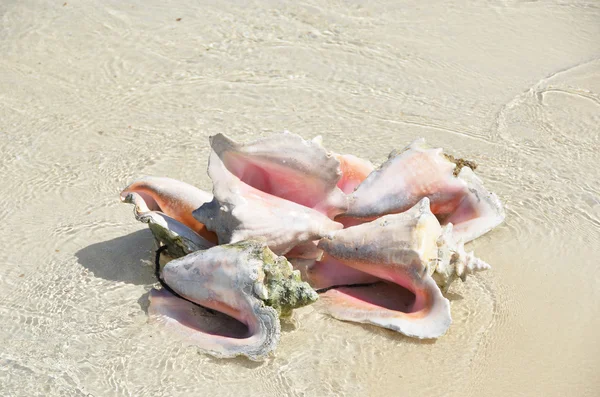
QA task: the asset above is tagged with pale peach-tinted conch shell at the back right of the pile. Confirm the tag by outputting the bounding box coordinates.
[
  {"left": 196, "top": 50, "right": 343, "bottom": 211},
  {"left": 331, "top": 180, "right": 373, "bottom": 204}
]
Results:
[{"left": 340, "top": 139, "right": 505, "bottom": 242}]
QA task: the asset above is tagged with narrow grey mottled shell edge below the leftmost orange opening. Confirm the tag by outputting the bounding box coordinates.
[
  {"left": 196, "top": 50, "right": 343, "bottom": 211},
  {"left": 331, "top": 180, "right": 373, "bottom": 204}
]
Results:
[{"left": 123, "top": 193, "right": 214, "bottom": 258}]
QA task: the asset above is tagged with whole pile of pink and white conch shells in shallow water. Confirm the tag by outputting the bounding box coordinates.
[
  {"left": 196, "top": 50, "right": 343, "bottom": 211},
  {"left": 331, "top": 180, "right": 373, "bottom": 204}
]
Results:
[{"left": 121, "top": 132, "right": 504, "bottom": 360}]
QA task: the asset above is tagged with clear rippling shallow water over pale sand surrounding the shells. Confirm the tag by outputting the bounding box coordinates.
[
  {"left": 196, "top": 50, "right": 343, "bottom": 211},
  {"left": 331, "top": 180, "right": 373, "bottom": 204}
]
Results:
[{"left": 0, "top": 0, "right": 600, "bottom": 396}]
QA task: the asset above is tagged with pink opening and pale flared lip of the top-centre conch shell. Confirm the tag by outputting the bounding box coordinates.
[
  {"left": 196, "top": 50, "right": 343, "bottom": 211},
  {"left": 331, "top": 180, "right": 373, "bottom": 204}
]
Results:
[{"left": 210, "top": 132, "right": 348, "bottom": 218}]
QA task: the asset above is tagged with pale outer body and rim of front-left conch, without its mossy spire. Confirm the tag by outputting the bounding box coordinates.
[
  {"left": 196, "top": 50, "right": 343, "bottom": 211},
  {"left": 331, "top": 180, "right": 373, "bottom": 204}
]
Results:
[{"left": 156, "top": 244, "right": 281, "bottom": 360}]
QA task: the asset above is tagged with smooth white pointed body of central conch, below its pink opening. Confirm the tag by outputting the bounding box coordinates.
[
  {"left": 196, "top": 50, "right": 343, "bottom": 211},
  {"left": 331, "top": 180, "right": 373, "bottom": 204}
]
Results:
[{"left": 193, "top": 151, "right": 343, "bottom": 255}]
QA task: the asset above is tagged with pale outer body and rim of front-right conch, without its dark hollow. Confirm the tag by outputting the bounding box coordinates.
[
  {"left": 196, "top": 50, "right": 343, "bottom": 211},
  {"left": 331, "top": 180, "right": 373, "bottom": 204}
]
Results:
[{"left": 319, "top": 198, "right": 452, "bottom": 338}]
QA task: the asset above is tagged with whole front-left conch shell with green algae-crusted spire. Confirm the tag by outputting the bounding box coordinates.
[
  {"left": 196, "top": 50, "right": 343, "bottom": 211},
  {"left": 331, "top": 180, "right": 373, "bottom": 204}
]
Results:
[{"left": 148, "top": 241, "right": 318, "bottom": 360}]
